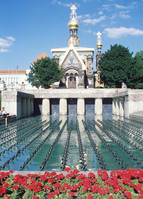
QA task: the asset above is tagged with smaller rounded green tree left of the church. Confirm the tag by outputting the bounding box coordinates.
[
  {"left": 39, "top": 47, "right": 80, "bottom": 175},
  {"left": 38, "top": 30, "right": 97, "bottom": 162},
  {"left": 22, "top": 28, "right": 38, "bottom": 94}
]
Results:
[{"left": 28, "top": 57, "right": 64, "bottom": 88}]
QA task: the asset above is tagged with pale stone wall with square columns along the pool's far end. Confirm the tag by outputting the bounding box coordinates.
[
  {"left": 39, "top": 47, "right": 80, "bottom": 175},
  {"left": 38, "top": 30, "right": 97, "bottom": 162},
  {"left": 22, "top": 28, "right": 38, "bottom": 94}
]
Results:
[{"left": 2, "top": 88, "right": 143, "bottom": 118}]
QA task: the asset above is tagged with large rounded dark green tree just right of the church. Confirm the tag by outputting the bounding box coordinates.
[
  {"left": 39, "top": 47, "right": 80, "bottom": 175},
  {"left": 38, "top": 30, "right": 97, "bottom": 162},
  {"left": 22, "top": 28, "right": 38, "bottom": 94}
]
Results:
[{"left": 99, "top": 44, "right": 133, "bottom": 88}]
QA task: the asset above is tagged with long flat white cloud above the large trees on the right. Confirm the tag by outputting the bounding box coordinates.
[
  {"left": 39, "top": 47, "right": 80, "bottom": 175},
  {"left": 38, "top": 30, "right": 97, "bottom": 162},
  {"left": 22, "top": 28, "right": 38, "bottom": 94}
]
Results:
[{"left": 104, "top": 27, "right": 143, "bottom": 38}]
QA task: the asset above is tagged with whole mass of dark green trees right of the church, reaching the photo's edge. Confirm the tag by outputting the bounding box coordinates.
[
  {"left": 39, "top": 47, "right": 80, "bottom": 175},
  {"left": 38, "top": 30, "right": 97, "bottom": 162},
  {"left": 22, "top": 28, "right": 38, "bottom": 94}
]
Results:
[{"left": 99, "top": 44, "right": 143, "bottom": 88}]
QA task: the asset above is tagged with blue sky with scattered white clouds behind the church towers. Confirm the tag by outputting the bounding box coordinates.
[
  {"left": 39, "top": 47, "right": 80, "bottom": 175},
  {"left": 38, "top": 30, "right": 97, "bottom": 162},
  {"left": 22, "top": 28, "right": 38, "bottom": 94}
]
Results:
[{"left": 0, "top": 0, "right": 143, "bottom": 70}]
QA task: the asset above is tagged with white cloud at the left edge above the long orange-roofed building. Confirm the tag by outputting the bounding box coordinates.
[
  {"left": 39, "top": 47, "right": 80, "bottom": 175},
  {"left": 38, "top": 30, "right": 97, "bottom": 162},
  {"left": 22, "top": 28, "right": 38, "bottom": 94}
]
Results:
[{"left": 0, "top": 36, "right": 15, "bottom": 52}]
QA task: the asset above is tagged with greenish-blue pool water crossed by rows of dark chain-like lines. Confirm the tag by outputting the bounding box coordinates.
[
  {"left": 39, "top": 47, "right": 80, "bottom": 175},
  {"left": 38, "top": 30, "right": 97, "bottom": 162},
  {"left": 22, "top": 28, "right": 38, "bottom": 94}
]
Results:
[{"left": 0, "top": 114, "right": 143, "bottom": 171}]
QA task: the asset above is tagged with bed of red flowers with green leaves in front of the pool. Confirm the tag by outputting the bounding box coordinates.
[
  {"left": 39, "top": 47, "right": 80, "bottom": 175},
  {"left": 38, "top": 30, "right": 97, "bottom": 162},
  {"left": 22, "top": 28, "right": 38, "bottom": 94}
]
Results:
[{"left": 0, "top": 168, "right": 143, "bottom": 199}]
